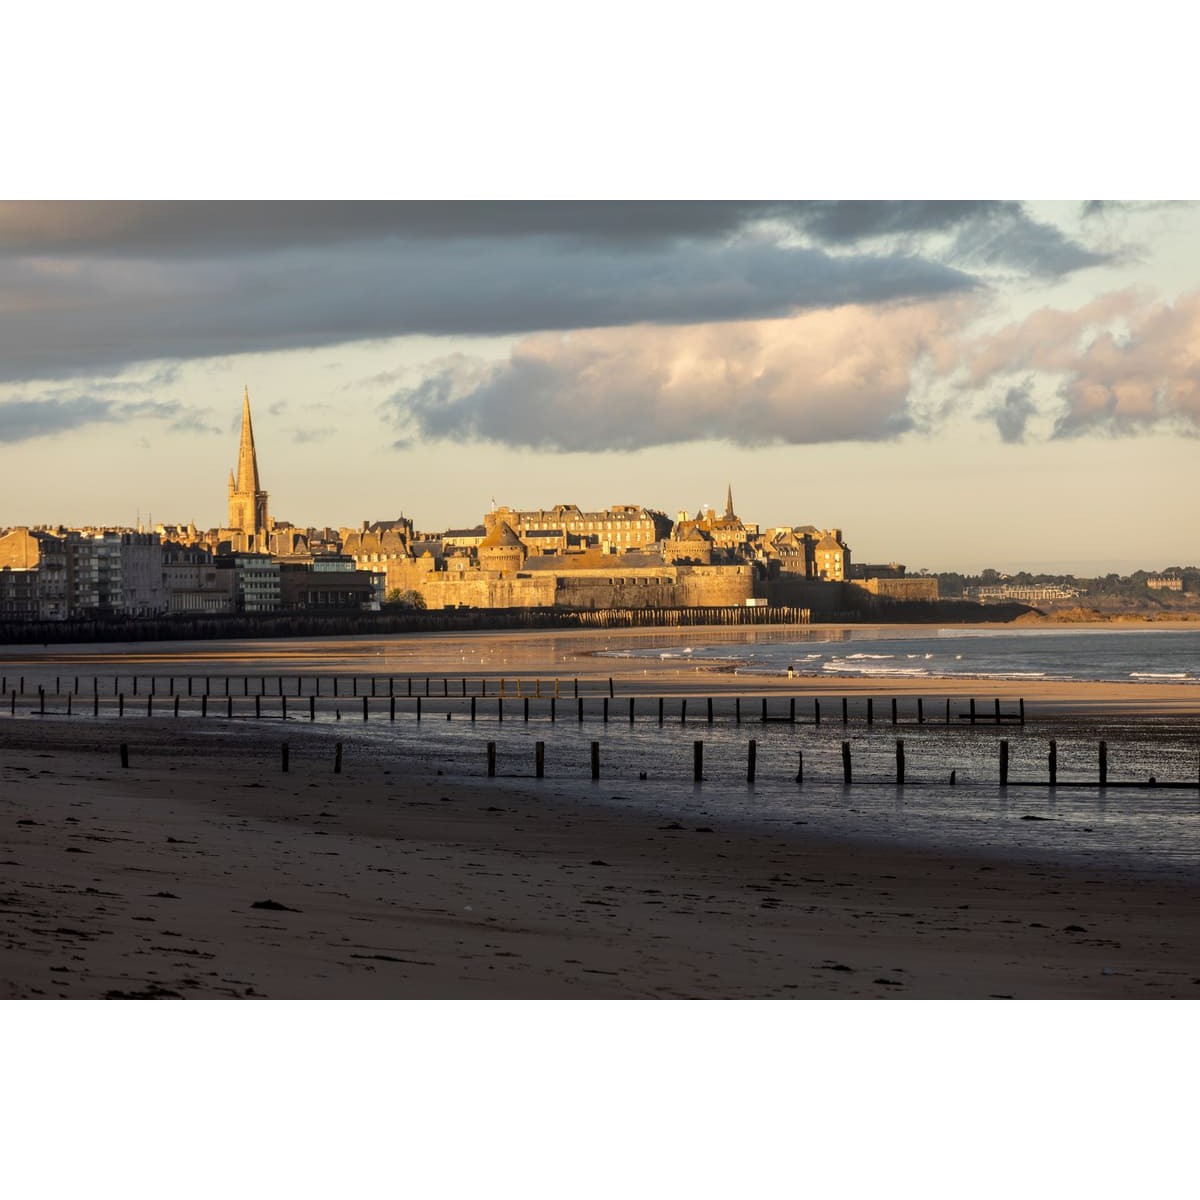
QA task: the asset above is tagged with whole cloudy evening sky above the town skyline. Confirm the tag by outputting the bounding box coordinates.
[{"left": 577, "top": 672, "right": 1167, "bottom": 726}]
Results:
[{"left": 0, "top": 200, "right": 1200, "bottom": 574}]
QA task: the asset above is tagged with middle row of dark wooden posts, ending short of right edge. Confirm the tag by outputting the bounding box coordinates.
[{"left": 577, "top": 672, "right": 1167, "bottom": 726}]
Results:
[{"left": 10, "top": 688, "right": 1025, "bottom": 726}]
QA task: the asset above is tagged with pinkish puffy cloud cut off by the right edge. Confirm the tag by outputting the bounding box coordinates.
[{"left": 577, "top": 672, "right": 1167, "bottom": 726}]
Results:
[{"left": 965, "top": 292, "right": 1200, "bottom": 437}]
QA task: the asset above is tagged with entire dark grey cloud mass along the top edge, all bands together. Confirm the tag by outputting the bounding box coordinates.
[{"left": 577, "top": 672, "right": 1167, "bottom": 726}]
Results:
[{"left": 0, "top": 200, "right": 1103, "bottom": 380}]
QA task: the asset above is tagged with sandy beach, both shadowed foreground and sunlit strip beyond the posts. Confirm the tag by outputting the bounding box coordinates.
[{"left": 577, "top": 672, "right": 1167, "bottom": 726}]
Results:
[{"left": 0, "top": 631, "right": 1200, "bottom": 998}]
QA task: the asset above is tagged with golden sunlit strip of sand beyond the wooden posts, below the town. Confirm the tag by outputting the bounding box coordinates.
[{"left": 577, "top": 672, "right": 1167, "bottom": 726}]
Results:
[{"left": 0, "top": 622, "right": 1200, "bottom": 718}]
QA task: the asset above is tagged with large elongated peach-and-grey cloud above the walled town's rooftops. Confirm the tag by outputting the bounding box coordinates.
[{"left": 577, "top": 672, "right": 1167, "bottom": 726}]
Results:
[{"left": 386, "top": 301, "right": 961, "bottom": 451}]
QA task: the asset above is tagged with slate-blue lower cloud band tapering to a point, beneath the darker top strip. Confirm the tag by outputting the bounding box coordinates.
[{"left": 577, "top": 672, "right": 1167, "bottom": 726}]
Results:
[{"left": 0, "top": 231, "right": 974, "bottom": 379}]
